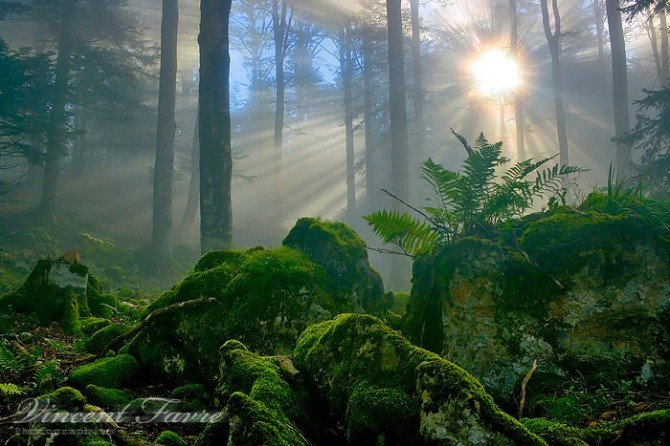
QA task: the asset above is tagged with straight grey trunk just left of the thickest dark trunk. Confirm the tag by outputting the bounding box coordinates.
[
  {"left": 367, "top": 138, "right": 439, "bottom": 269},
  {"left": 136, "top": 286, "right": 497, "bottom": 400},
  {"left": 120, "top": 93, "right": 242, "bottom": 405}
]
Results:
[{"left": 152, "top": 0, "right": 179, "bottom": 257}]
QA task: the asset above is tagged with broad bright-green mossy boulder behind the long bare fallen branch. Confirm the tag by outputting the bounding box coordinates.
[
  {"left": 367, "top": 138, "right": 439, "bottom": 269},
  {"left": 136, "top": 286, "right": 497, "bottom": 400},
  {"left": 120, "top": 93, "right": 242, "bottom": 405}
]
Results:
[{"left": 129, "top": 247, "right": 353, "bottom": 387}]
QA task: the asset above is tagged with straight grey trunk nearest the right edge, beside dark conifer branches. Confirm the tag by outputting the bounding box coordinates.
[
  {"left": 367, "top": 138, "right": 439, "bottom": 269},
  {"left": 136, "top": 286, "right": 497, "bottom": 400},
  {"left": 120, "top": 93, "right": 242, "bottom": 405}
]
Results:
[{"left": 605, "top": 0, "right": 630, "bottom": 176}]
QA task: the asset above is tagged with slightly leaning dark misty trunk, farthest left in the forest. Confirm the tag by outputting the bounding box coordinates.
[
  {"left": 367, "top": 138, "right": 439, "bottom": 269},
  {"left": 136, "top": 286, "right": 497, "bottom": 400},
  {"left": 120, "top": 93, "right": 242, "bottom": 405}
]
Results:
[{"left": 39, "top": 0, "right": 76, "bottom": 219}]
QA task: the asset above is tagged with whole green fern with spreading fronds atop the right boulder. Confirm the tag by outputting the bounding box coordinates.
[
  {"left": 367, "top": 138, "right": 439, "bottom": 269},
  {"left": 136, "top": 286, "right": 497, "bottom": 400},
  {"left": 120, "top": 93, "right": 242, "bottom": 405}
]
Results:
[{"left": 364, "top": 130, "right": 583, "bottom": 254}]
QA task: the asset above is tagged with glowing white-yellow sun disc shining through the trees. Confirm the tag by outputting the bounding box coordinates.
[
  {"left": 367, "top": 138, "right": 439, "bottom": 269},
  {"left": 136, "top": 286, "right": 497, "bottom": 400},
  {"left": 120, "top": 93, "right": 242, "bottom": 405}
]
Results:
[{"left": 470, "top": 49, "right": 521, "bottom": 98}]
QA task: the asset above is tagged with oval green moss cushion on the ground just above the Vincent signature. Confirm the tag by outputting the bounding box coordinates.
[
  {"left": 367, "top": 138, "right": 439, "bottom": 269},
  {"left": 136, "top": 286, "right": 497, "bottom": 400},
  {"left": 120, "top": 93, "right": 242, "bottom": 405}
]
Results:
[{"left": 69, "top": 355, "right": 138, "bottom": 389}]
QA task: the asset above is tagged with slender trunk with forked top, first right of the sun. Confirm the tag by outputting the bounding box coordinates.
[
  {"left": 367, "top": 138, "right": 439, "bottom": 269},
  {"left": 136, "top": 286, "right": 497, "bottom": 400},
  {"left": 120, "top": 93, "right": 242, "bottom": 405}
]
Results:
[{"left": 540, "top": 0, "right": 569, "bottom": 166}]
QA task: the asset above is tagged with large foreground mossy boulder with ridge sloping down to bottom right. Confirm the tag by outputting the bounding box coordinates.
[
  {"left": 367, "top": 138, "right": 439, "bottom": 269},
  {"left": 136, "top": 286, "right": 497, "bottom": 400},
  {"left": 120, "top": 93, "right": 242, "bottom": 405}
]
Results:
[{"left": 295, "top": 314, "right": 546, "bottom": 445}]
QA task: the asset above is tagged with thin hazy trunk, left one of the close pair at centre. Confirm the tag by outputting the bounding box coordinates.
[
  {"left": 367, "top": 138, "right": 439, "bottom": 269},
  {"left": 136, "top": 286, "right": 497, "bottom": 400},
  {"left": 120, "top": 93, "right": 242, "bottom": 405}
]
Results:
[{"left": 339, "top": 23, "right": 356, "bottom": 221}]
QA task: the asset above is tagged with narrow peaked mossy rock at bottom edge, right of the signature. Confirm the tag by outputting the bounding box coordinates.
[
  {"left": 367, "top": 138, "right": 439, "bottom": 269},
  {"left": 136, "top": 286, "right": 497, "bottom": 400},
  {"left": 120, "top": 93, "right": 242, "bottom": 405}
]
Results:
[{"left": 196, "top": 341, "right": 310, "bottom": 446}]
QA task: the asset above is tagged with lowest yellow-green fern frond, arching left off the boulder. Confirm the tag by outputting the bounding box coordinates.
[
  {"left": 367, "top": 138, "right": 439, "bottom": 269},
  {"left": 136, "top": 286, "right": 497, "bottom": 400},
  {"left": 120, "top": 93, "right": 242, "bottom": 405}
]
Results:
[{"left": 363, "top": 210, "right": 439, "bottom": 255}]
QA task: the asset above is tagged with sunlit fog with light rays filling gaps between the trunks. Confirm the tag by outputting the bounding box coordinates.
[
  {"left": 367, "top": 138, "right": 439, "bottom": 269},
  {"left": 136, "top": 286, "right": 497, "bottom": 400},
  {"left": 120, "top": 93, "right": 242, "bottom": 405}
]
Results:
[{"left": 0, "top": 0, "right": 667, "bottom": 288}]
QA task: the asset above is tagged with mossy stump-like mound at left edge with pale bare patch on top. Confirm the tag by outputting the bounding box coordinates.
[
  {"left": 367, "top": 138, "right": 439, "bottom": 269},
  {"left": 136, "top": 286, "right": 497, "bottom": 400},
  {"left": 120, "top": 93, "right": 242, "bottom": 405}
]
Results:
[{"left": 0, "top": 259, "right": 113, "bottom": 334}]
